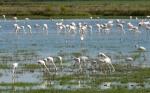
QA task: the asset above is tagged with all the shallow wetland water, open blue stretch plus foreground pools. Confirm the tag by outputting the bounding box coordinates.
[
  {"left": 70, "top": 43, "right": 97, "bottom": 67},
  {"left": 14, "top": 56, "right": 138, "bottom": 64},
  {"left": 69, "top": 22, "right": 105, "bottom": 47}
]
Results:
[{"left": 0, "top": 19, "right": 150, "bottom": 89}]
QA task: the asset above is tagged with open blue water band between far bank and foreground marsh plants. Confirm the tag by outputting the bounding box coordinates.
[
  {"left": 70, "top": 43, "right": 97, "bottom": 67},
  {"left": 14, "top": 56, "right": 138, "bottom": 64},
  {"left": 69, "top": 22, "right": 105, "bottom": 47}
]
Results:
[{"left": 0, "top": 19, "right": 150, "bottom": 57}]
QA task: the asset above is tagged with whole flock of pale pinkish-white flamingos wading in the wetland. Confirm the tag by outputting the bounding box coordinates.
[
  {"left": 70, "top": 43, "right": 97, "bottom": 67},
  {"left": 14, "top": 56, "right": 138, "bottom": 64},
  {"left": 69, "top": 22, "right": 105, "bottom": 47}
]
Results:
[{"left": 0, "top": 15, "right": 150, "bottom": 83}]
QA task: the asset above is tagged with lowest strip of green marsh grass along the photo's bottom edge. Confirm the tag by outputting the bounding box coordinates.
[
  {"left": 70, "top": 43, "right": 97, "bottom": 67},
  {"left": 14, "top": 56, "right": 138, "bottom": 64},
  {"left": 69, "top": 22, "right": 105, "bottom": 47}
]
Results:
[{"left": 0, "top": 88, "right": 150, "bottom": 93}]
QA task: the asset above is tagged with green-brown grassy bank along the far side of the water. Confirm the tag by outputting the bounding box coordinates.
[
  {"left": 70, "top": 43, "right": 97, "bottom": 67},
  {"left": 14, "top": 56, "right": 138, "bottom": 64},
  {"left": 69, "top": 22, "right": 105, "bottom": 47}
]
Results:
[{"left": 0, "top": 0, "right": 150, "bottom": 18}]
